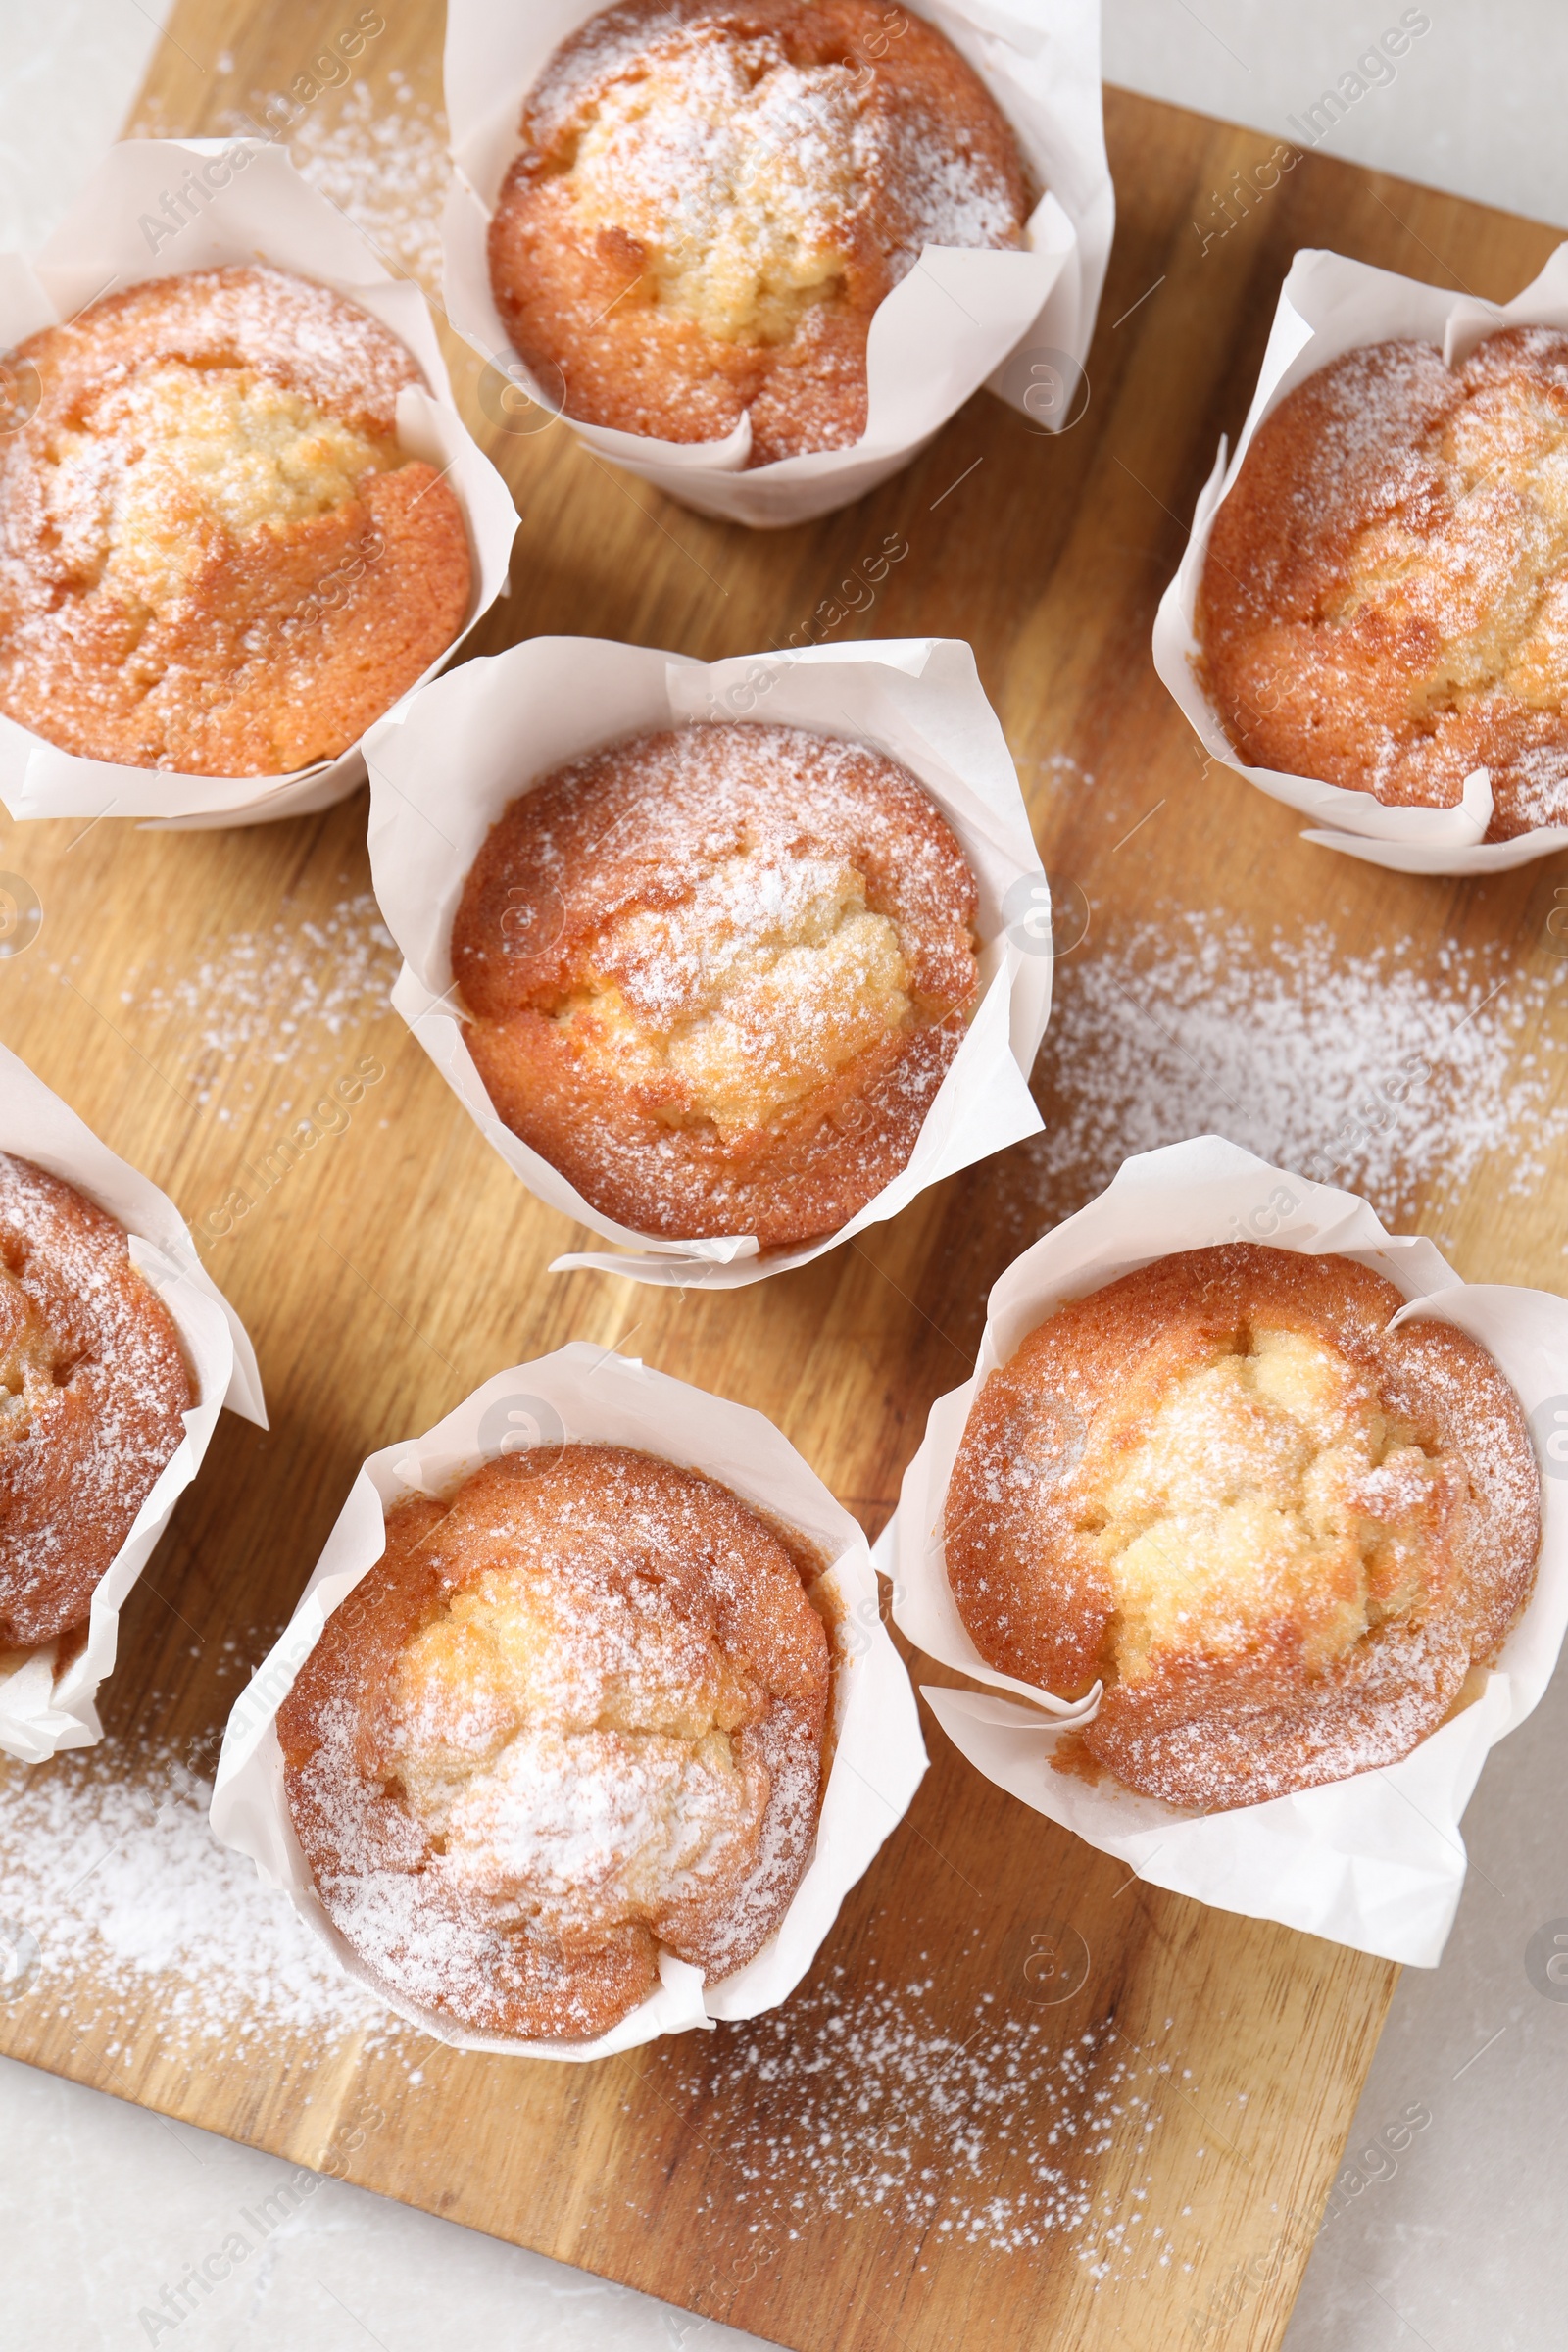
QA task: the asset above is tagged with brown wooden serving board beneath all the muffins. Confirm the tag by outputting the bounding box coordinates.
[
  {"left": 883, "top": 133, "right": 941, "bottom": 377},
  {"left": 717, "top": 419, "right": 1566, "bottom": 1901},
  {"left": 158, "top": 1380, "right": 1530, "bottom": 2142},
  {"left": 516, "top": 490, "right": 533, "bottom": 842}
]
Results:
[{"left": 0, "top": 0, "right": 1566, "bottom": 2352}]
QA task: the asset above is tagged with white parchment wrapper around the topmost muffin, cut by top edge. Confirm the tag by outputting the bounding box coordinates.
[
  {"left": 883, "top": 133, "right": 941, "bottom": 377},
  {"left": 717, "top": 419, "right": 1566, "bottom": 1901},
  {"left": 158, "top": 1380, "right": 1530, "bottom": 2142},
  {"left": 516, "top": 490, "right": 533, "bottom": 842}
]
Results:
[{"left": 442, "top": 0, "right": 1116, "bottom": 529}]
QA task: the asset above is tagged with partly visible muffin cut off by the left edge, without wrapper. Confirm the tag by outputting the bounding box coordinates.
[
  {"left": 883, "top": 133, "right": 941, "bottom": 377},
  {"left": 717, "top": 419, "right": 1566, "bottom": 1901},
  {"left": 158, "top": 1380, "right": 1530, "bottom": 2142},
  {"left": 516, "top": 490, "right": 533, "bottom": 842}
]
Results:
[{"left": 0, "top": 1152, "right": 195, "bottom": 1651}]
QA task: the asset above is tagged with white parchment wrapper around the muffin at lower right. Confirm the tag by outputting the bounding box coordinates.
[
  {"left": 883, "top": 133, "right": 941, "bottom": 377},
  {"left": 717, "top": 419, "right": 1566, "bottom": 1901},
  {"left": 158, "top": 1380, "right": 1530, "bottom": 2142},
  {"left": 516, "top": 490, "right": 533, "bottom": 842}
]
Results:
[{"left": 877, "top": 1136, "right": 1568, "bottom": 1969}]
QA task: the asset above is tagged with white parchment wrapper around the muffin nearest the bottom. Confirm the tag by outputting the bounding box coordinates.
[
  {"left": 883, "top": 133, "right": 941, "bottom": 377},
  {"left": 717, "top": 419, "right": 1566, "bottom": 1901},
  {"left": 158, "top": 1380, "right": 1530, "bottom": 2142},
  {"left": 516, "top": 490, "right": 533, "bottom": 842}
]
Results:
[{"left": 212, "top": 1341, "right": 926, "bottom": 2060}]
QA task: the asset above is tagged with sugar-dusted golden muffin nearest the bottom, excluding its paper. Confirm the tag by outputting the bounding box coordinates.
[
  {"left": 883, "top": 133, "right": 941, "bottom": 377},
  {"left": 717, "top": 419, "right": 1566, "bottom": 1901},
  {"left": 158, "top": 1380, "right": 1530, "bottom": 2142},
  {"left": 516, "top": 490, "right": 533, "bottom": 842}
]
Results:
[{"left": 277, "top": 1445, "right": 830, "bottom": 2039}]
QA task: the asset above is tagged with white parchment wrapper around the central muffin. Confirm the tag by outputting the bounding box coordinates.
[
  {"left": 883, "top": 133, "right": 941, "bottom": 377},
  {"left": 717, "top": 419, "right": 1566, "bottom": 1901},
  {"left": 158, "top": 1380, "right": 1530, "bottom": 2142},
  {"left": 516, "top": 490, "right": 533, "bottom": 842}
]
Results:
[{"left": 365, "top": 637, "right": 1051, "bottom": 1289}]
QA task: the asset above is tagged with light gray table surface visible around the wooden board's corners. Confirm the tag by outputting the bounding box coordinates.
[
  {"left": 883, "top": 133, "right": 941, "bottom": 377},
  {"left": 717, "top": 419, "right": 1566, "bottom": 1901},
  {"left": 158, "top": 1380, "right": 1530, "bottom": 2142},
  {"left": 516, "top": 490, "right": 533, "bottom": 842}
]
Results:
[{"left": 0, "top": 0, "right": 1568, "bottom": 2352}]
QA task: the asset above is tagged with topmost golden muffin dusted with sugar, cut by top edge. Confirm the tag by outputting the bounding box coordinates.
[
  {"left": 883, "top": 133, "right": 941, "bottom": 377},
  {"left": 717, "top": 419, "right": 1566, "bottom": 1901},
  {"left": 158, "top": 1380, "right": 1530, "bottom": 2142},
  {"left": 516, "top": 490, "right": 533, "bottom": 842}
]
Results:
[{"left": 489, "top": 0, "right": 1030, "bottom": 466}]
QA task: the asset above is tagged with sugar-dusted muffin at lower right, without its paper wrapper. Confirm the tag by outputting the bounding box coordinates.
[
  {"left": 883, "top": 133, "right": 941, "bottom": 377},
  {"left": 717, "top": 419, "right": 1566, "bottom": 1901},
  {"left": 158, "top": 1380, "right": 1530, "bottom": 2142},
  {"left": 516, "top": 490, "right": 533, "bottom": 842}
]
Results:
[{"left": 943, "top": 1242, "right": 1540, "bottom": 1811}]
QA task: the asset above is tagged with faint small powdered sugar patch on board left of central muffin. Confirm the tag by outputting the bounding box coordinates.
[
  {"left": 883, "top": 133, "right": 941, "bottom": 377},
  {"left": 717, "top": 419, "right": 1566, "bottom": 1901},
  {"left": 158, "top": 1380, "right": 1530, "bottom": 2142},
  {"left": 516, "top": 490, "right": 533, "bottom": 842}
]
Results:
[{"left": 107, "top": 892, "right": 400, "bottom": 1101}]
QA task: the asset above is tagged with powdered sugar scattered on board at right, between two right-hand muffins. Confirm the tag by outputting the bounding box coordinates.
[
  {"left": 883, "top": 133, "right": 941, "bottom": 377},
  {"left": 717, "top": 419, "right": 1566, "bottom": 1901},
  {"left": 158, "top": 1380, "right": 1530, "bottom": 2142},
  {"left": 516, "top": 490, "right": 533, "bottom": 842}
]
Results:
[{"left": 1020, "top": 910, "right": 1568, "bottom": 1225}]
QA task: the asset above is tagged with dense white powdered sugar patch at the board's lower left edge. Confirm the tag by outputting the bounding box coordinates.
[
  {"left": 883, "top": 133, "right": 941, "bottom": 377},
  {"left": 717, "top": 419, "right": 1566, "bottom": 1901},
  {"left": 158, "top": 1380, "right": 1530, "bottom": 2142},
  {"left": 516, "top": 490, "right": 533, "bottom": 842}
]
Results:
[{"left": 0, "top": 1745, "right": 402, "bottom": 2063}]
